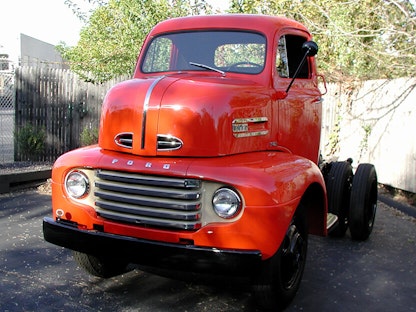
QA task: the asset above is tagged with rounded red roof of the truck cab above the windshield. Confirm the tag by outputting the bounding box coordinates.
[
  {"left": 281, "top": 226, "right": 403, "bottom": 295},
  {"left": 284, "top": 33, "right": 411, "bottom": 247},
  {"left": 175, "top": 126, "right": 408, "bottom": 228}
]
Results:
[{"left": 151, "top": 14, "right": 309, "bottom": 35}]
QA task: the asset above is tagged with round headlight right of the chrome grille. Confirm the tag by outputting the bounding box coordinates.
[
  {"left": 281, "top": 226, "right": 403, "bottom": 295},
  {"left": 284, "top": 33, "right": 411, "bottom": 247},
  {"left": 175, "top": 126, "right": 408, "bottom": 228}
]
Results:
[{"left": 212, "top": 188, "right": 241, "bottom": 219}]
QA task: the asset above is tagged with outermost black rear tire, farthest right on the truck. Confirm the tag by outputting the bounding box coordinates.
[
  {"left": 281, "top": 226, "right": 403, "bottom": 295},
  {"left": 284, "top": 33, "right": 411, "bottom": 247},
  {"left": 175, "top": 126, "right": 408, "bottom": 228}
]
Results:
[{"left": 349, "top": 164, "right": 378, "bottom": 241}]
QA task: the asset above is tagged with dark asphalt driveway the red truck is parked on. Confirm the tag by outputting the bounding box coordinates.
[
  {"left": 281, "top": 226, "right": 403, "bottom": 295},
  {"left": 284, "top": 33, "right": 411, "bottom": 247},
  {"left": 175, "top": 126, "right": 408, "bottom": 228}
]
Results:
[{"left": 0, "top": 190, "right": 416, "bottom": 312}]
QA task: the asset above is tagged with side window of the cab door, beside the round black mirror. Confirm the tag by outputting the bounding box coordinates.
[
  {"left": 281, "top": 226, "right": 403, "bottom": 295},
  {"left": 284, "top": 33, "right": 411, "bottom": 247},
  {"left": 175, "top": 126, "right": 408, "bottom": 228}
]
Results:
[{"left": 276, "top": 35, "right": 309, "bottom": 78}]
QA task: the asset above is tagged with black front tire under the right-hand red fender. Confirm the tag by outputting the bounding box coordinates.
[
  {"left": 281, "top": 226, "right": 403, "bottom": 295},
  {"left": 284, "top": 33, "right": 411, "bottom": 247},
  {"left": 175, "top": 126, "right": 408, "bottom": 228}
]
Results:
[{"left": 254, "top": 206, "right": 308, "bottom": 311}]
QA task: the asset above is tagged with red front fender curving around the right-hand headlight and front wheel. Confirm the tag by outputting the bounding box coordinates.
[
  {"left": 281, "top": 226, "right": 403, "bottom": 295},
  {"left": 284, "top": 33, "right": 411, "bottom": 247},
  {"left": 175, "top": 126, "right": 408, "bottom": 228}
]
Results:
[{"left": 187, "top": 152, "right": 327, "bottom": 259}]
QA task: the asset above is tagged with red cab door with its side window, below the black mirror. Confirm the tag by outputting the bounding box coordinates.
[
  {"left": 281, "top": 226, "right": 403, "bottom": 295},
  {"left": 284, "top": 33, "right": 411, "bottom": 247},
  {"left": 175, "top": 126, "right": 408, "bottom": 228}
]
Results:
[{"left": 274, "top": 34, "right": 322, "bottom": 163}]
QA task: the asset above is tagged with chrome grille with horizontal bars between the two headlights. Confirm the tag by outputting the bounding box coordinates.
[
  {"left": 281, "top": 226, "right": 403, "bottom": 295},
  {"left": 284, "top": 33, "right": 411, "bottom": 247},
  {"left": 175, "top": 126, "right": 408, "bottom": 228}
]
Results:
[{"left": 94, "top": 170, "right": 201, "bottom": 230}]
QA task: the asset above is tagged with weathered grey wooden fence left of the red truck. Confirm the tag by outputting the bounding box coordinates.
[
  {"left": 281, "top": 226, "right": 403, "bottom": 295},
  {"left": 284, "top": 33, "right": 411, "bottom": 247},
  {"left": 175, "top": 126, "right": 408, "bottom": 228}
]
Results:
[{"left": 15, "top": 67, "right": 128, "bottom": 161}]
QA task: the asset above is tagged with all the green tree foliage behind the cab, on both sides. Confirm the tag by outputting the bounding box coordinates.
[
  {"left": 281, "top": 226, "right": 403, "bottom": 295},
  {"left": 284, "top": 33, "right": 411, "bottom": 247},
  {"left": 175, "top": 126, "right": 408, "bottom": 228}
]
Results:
[{"left": 59, "top": 0, "right": 416, "bottom": 82}]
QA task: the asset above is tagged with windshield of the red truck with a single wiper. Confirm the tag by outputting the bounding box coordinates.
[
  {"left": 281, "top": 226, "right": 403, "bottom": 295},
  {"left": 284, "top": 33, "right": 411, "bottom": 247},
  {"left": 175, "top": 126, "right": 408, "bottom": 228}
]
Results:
[{"left": 141, "top": 31, "right": 266, "bottom": 74}]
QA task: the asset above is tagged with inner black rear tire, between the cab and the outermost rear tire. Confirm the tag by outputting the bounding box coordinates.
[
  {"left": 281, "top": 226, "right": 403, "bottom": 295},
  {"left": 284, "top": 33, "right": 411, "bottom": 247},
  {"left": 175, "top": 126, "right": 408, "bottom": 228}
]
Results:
[{"left": 325, "top": 161, "right": 353, "bottom": 237}]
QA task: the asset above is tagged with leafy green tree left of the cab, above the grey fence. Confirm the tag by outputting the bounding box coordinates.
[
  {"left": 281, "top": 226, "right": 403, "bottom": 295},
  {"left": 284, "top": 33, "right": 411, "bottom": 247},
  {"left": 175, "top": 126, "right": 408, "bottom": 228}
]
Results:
[{"left": 58, "top": 0, "right": 210, "bottom": 82}]
